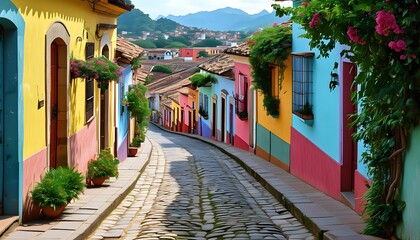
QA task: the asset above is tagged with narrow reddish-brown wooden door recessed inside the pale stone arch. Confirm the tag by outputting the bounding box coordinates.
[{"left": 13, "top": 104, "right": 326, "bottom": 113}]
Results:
[{"left": 50, "top": 42, "right": 58, "bottom": 168}]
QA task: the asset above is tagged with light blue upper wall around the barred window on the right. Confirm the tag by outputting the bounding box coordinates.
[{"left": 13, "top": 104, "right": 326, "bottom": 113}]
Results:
[{"left": 292, "top": 24, "right": 341, "bottom": 162}]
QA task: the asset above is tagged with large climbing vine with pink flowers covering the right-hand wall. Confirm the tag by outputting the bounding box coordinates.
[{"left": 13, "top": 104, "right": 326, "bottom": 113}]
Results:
[{"left": 273, "top": 0, "right": 420, "bottom": 237}]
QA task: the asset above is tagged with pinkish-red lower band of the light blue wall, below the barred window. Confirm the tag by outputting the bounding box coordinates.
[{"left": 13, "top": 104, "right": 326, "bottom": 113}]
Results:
[{"left": 290, "top": 128, "right": 341, "bottom": 200}]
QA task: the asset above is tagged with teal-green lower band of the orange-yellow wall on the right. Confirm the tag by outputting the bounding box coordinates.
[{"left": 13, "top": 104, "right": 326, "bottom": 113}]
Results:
[{"left": 256, "top": 123, "right": 290, "bottom": 166}]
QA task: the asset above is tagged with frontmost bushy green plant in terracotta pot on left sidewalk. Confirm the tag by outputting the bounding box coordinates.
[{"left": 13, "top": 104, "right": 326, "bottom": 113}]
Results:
[{"left": 31, "top": 174, "right": 68, "bottom": 218}]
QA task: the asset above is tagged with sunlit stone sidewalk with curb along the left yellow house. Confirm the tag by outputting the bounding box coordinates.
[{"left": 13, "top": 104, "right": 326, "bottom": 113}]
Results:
[{"left": 1, "top": 140, "right": 152, "bottom": 240}]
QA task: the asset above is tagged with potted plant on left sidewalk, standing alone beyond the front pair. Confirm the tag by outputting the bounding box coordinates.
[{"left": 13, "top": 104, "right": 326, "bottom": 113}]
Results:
[{"left": 86, "top": 149, "right": 120, "bottom": 186}]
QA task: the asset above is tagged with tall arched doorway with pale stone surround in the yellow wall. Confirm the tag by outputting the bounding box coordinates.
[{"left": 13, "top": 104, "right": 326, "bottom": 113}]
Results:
[{"left": 46, "top": 22, "right": 70, "bottom": 168}]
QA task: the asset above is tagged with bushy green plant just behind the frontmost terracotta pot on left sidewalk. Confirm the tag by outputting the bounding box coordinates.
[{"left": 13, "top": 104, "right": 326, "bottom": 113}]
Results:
[{"left": 44, "top": 167, "right": 85, "bottom": 202}]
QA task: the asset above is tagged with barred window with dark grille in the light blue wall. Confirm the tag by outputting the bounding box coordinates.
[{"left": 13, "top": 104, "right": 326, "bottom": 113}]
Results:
[{"left": 292, "top": 52, "right": 314, "bottom": 119}]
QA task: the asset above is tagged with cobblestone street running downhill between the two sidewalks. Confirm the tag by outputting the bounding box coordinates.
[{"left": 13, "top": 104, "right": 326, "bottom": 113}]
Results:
[{"left": 90, "top": 126, "right": 314, "bottom": 240}]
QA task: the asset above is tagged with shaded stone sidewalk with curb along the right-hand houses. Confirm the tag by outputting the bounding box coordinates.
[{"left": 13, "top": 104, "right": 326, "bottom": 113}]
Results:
[{"left": 152, "top": 126, "right": 380, "bottom": 240}]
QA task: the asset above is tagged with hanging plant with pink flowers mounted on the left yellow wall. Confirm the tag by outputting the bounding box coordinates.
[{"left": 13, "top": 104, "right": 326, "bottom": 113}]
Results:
[{"left": 70, "top": 56, "right": 124, "bottom": 92}]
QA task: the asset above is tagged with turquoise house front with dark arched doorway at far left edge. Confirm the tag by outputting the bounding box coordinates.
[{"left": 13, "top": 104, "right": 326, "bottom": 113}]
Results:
[{"left": 0, "top": 0, "right": 25, "bottom": 217}]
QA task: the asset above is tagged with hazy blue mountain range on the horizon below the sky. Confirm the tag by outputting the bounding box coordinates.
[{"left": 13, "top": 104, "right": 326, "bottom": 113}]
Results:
[{"left": 166, "top": 7, "right": 282, "bottom": 31}]
